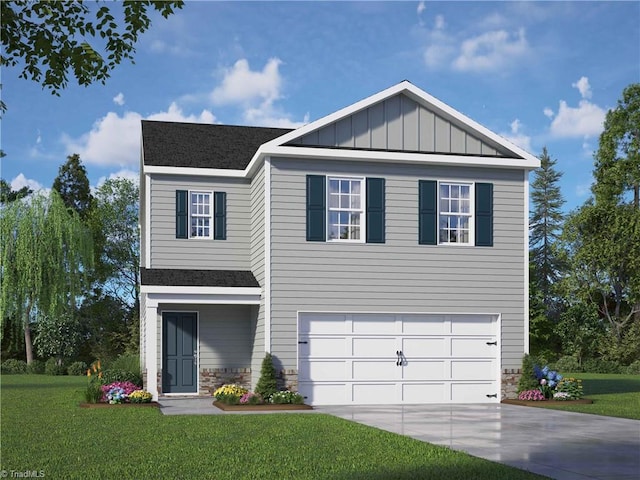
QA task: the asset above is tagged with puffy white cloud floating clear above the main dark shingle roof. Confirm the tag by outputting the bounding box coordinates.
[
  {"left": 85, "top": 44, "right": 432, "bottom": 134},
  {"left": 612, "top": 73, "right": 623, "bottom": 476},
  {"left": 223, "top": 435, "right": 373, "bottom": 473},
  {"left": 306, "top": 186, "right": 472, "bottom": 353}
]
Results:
[{"left": 211, "top": 58, "right": 282, "bottom": 105}]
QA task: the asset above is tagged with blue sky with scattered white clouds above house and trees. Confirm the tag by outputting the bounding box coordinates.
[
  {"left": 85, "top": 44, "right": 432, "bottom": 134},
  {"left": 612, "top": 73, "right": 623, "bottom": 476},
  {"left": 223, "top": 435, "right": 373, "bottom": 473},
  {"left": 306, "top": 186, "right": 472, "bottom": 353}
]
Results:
[{"left": 0, "top": 2, "right": 640, "bottom": 209}]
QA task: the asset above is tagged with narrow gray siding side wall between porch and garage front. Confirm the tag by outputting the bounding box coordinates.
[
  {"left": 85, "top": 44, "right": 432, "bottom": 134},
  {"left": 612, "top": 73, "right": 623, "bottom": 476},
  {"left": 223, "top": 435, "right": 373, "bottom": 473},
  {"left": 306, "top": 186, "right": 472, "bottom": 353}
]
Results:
[{"left": 250, "top": 163, "right": 266, "bottom": 376}]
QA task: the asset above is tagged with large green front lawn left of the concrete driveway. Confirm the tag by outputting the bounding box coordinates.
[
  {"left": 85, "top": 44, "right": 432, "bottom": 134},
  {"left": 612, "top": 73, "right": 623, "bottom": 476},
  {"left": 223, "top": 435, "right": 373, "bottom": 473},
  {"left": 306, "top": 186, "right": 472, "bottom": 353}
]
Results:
[{"left": 0, "top": 375, "right": 544, "bottom": 480}]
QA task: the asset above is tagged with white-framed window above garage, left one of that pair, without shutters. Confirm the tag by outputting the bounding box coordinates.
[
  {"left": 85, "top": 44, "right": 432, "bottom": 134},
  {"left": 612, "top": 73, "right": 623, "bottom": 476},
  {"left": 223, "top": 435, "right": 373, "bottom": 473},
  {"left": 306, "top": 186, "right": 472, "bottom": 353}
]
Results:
[{"left": 328, "top": 177, "right": 364, "bottom": 241}]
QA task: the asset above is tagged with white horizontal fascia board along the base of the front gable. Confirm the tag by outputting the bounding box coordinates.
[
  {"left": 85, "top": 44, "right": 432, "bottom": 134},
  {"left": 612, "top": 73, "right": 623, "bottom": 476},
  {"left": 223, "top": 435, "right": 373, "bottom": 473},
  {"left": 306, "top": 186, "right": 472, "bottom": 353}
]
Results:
[{"left": 263, "top": 146, "right": 540, "bottom": 170}]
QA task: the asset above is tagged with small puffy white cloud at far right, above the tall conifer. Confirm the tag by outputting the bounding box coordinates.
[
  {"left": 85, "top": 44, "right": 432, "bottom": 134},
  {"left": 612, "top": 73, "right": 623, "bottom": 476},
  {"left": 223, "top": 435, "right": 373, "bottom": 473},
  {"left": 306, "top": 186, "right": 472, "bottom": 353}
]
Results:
[{"left": 551, "top": 99, "right": 606, "bottom": 137}]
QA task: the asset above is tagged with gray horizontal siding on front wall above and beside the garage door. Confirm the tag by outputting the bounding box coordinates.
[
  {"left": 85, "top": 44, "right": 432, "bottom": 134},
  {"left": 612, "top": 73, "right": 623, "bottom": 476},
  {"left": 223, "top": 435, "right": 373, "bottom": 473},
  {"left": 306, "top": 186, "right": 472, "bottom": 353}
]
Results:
[{"left": 271, "top": 159, "right": 525, "bottom": 368}]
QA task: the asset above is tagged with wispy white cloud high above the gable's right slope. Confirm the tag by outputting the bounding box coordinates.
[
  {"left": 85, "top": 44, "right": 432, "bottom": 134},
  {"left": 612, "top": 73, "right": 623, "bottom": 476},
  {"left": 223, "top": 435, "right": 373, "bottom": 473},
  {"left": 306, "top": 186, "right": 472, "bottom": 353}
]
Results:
[{"left": 453, "top": 28, "right": 529, "bottom": 72}]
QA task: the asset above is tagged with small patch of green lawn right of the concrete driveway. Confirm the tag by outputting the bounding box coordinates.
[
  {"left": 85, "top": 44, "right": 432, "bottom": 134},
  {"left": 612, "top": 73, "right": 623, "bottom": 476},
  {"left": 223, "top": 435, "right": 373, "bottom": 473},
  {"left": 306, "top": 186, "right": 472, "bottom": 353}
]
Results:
[{"left": 524, "top": 373, "right": 640, "bottom": 420}]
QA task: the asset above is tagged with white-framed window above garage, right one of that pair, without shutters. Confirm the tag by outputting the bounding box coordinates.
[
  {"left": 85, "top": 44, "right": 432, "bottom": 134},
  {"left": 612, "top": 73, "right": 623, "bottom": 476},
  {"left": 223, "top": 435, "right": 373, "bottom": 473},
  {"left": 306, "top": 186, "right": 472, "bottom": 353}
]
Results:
[{"left": 438, "top": 183, "right": 472, "bottom": 244}]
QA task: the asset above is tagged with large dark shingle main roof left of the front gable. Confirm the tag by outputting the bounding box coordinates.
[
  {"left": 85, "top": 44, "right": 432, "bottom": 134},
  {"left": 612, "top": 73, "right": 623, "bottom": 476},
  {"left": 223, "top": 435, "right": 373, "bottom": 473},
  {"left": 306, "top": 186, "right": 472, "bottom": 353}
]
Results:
[{"left": 142, "top": 120, "right": 291, "bottom": 170}]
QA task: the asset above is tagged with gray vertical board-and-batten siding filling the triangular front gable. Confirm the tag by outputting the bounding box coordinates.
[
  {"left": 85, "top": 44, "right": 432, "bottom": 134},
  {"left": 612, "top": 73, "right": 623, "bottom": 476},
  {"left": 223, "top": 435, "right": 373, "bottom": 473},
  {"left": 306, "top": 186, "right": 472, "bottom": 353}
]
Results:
[{"left": 290, "top": 94, "right": 511, "bottom": 157}]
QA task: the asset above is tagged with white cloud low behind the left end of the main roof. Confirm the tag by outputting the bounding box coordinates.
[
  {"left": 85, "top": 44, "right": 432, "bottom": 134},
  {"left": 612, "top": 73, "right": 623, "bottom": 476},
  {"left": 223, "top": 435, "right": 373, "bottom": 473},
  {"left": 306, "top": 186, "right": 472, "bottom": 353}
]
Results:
[{"left": 62, "top": 103, "right": 215, "bottom": 167}]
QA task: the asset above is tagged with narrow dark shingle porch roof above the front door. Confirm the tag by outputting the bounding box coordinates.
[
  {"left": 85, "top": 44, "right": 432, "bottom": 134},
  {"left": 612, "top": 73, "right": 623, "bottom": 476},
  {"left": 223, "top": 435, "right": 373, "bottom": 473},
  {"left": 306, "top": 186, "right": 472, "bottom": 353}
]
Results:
[{"left": 140, "top": 268, "right": 260, "bottom": 287}]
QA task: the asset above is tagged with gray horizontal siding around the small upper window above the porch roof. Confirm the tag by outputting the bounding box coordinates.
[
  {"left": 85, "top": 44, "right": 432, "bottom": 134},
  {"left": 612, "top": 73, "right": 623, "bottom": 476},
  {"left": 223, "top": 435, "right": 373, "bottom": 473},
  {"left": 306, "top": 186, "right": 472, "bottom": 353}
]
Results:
[{"left": 150, "top": 175, "right": 251, "bottom": 270}]
